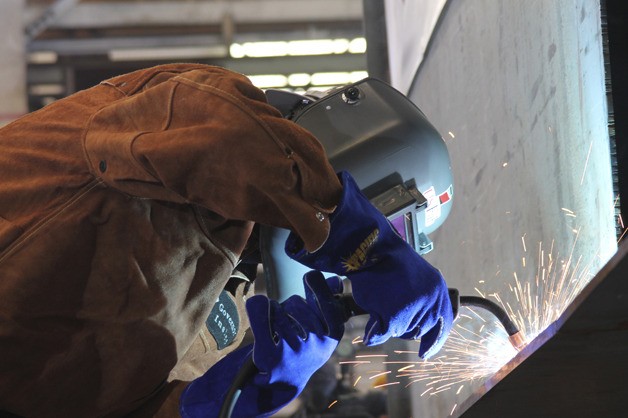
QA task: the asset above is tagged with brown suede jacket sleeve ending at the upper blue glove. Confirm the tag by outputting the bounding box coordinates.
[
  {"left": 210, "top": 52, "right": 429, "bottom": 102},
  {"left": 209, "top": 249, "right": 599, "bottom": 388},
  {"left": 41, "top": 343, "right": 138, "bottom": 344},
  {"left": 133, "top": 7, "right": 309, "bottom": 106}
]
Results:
[{"left": 83, "top": 66, "right": 341, "bottom": 251}]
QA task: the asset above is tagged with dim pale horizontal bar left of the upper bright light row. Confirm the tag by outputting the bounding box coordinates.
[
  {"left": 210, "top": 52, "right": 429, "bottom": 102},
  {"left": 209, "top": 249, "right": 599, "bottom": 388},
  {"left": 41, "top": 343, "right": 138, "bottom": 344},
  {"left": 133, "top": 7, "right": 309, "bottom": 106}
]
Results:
[{"left": 108, "top": 45, "right": 228, "bottom": 62}]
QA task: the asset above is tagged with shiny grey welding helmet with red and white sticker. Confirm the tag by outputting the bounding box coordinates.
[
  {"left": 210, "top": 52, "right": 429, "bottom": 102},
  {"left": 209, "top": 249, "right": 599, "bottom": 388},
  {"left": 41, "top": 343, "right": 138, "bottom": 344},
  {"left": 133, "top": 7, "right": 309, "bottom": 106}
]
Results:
[{"left": 262, "top": 78, "right": 453, "bottom": 300}]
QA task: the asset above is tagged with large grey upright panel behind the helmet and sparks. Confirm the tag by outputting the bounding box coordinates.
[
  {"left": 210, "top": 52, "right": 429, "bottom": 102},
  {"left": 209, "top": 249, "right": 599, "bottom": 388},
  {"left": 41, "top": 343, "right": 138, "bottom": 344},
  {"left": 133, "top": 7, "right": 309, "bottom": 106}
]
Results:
[{"left": 392, "top": 0, "right": 616, "bottom": 417}]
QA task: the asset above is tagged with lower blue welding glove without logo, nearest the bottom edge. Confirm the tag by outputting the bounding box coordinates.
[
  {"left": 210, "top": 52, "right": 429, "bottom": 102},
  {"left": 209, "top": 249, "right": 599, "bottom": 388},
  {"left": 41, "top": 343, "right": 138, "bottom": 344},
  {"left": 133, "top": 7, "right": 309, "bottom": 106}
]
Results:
[{"left": 180, "top": 271, "right": 344, "bottom": 418}]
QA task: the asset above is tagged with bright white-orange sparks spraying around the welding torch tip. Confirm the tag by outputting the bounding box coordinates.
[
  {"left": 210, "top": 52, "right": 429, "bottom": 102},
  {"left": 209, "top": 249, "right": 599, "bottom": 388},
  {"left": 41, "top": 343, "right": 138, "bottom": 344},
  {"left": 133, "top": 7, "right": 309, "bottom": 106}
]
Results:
[{"left": 342, "top": 230, "right": 595, "bottom": 416}]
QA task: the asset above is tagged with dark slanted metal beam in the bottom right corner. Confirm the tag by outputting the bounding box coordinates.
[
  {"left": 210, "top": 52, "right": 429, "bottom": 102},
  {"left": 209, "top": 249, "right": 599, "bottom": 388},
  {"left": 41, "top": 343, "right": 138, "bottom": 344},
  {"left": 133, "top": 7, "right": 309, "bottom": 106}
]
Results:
[{"left": 459, "top": 244, "right": 628, "bottom": 418}]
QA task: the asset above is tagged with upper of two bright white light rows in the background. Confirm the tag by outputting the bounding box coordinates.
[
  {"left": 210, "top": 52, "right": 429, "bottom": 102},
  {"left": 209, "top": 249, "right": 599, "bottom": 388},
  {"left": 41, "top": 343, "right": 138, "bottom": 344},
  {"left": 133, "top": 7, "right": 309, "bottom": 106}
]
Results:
[{"left": 229, "top": 38, "right": 366, "bottom": 58}]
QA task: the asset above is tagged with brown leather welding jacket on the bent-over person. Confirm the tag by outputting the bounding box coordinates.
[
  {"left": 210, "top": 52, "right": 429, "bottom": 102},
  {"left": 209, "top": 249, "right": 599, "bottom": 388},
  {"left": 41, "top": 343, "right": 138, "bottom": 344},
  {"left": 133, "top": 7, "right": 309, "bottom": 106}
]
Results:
[{"left": 0, "top": 64, "right": 341, "bottom": 417}]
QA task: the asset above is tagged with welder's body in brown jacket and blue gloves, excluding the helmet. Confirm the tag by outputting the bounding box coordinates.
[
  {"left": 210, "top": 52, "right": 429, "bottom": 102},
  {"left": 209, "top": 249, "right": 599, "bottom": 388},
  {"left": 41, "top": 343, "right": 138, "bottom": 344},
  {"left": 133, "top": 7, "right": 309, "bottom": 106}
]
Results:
[{"left": 0, "top": 64, "right": 452, "bottom": 417}]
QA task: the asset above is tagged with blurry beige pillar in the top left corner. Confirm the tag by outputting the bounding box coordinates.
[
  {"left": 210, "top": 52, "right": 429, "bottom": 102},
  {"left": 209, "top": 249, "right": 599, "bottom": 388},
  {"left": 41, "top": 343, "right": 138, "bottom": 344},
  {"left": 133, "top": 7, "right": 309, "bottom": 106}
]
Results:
[{"left": 0, "top": 0, "right": 27, "bottom": 126}]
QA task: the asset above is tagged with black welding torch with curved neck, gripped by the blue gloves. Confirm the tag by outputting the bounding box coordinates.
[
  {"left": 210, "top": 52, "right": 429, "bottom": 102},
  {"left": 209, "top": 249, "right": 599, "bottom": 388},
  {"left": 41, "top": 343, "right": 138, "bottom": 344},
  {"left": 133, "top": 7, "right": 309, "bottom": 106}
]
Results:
[{"left": 218, "top": 287, "right": 525, "bottom": 418}]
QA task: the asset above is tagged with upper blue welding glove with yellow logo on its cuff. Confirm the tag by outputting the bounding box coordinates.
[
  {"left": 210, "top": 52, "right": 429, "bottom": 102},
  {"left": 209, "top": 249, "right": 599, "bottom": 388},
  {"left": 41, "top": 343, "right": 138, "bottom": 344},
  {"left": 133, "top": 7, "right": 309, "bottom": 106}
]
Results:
[{"left": 286, "top": 172, "right": 453, "bottom": 358}]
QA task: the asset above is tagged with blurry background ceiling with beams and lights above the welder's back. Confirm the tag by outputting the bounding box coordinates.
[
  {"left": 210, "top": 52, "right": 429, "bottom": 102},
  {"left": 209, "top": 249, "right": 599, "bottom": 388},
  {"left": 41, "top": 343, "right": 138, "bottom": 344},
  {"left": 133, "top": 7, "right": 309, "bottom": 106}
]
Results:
[{"left": 24, "top": 0, "right": 366, "bottom": 110}]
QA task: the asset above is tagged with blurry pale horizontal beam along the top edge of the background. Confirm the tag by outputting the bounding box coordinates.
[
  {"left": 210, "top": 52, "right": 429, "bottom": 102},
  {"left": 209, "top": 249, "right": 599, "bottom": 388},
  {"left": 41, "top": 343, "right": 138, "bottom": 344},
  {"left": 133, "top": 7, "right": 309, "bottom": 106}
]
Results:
[{"left": 26, "top": 0, "right": 362, "bottom": 29}]
